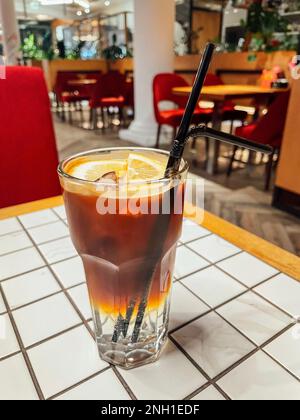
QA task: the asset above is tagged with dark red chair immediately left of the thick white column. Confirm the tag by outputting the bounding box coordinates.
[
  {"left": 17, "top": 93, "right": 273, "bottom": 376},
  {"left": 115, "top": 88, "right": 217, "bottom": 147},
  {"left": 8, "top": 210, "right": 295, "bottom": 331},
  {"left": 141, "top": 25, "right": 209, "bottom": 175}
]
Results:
[{"left": 90, "top": 71, "right": 126, "bottom": 129}]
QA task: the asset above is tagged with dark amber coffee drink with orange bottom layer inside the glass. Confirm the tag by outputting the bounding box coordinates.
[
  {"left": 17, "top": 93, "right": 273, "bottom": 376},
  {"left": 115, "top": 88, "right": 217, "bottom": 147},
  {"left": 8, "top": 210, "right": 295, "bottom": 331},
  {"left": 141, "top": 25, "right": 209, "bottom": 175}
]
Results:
[{"left": 64, "top": 185, "right": 184, "bottom": 319}]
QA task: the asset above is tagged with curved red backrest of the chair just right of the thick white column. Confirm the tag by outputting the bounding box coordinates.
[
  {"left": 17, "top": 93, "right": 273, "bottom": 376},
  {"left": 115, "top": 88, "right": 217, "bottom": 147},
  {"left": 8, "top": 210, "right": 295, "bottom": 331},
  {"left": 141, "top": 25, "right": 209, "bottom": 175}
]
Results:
[{"left": 153, "top": 73, "right": 189, "bottom": 120}]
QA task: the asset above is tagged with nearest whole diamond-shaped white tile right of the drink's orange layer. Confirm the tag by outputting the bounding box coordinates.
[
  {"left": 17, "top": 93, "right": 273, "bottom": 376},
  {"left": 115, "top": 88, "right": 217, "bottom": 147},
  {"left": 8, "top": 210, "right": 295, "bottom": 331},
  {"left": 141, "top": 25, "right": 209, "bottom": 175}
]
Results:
[{"left": 182, "top": 267, "right": 246, "bottom": 307}]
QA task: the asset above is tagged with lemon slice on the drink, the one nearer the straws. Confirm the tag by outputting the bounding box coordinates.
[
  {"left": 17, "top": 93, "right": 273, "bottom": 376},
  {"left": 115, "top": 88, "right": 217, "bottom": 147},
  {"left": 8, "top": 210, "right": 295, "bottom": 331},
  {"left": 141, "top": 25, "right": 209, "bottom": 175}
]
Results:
[{"left": 127, "top": 153, "right": 166, "bottom": 181}]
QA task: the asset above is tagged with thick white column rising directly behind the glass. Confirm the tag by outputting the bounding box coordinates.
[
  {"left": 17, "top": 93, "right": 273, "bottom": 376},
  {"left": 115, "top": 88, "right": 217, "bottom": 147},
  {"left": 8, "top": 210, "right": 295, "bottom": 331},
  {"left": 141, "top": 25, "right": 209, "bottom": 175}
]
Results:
[{"left": 120, "top": 0, "right": 175, "bottom": 147}]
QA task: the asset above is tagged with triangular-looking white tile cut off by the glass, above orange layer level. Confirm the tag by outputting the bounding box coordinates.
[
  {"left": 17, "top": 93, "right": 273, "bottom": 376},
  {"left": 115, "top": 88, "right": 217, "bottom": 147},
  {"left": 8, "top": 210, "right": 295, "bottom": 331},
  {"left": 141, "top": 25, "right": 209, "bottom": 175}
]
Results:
[{"left": 174, "top": 246, "right": 209, "bottom": 279}]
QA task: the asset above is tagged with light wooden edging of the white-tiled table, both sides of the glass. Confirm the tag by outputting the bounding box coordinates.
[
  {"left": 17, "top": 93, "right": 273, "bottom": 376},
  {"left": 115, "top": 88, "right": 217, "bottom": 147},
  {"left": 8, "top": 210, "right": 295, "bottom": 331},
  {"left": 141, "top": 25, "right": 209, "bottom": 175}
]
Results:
[{"left": 0, "top": 196, "right": 300, "bottom": 281}]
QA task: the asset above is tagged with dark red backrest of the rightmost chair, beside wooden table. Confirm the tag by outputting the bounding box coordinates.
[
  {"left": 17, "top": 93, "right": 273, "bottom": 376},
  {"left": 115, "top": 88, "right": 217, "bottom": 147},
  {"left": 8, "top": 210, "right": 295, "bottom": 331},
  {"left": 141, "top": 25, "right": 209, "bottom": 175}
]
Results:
[{"left": 247, "top": 92, "right": 290, "bottom": 146}]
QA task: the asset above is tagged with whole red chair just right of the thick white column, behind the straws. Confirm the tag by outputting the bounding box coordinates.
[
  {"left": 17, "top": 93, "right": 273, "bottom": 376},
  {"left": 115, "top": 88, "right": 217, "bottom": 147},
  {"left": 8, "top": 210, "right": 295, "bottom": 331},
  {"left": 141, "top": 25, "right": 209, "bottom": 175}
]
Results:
[{"left": 153, "top": 73, "right": 213, "bottom": 148}]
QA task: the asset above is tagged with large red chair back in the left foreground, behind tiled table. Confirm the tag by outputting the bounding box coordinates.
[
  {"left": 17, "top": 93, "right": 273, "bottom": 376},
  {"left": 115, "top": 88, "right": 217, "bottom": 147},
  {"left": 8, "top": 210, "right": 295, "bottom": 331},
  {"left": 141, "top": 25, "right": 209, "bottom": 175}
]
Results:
[{"left": 0, "top": 67, "right": 61, "bottom": 208}]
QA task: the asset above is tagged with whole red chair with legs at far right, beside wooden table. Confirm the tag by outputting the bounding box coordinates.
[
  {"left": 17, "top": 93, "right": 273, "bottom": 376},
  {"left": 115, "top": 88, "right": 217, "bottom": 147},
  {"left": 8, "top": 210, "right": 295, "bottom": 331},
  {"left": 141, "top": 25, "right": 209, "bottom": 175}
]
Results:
[{"left": 227, "top": 92, "right": 290, "bottom": 191}]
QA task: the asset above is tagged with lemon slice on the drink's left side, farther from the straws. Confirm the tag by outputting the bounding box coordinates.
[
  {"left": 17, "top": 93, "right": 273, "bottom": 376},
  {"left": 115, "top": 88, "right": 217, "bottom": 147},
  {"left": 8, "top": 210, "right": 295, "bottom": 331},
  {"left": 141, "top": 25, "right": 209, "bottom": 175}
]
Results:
[{"left": 68, "top": 160, "right": 127, "bottom": 181}]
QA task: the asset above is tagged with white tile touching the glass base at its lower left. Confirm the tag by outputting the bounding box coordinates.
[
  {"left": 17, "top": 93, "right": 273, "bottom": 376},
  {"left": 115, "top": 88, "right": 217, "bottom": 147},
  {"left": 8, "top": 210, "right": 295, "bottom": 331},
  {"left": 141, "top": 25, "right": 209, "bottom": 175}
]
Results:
[{"left": 28, "top": 326, "right": 108, "bottom": 398}]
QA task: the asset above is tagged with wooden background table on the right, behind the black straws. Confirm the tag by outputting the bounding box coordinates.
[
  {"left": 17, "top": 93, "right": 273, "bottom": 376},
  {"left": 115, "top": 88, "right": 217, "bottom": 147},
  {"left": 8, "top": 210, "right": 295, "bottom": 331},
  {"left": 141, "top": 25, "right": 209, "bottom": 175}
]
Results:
[{"left": 173, "top": 85, "right": 286, "bottom": 175}]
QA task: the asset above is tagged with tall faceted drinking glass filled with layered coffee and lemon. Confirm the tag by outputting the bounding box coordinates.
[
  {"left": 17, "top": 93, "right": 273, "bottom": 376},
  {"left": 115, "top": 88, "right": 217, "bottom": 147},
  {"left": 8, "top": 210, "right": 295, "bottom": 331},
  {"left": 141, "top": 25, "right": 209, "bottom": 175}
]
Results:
[{"left": 59, "top": 148, "right": 188, "bottom": 369}]
